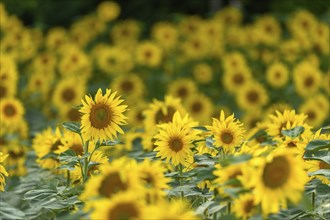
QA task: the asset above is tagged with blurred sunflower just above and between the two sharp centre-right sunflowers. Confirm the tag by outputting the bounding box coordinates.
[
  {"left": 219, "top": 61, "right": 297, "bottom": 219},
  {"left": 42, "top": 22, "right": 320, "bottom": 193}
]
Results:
[{"left": 185, "top": 93, "right": 213, "bottom": 123}]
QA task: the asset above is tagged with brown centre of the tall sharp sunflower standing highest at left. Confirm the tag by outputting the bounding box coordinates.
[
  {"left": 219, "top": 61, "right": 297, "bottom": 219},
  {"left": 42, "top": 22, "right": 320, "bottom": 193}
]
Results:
[{"left": 90, "top": 103, "right": 112, "bottom": 129}]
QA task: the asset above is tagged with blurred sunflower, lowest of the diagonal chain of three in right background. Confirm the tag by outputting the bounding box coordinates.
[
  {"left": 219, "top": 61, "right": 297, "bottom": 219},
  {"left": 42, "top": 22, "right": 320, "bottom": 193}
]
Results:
[{"left": 236, "top": 82, "right": 268, "bottom": 110}]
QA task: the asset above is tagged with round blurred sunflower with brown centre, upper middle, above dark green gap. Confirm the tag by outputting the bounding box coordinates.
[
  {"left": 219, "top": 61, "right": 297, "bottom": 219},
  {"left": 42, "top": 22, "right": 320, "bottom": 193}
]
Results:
[{"left": 136, "top": 41, "right": 163, "bottom": 67}]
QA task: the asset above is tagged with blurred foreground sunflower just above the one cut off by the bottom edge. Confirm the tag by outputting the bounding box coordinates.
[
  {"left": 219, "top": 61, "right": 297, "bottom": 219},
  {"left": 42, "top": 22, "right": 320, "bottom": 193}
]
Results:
[{"left": 80, "top": 157, "right": 143, "bottom": 201}]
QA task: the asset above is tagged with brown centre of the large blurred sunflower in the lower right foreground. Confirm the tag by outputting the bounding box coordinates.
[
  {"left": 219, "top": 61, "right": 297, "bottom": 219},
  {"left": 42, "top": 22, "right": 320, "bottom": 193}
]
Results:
[{"left": 262, "top": 156, "right": 290, "bottom": 189}]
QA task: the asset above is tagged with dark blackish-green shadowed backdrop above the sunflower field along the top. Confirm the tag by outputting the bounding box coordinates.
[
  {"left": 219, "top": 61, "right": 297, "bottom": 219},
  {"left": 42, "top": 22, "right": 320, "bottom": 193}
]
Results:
[{"left": 0, "top": 0, "right": 330, "bottom": 30}]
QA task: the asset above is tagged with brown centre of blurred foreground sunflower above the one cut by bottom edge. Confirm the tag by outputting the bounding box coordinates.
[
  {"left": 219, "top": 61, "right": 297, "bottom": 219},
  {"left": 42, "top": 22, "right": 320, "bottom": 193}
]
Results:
[{"left": 99, "top": 172, "right": 128, "bottom": 197}]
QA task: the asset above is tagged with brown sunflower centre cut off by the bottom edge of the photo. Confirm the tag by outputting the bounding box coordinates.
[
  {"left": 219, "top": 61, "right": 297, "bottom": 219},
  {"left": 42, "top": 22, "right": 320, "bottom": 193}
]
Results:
[{"left": 108, "top": 202, "right": 140, "bottom": 220}]
